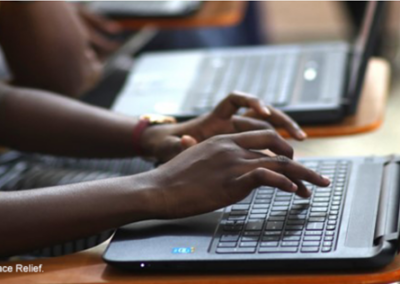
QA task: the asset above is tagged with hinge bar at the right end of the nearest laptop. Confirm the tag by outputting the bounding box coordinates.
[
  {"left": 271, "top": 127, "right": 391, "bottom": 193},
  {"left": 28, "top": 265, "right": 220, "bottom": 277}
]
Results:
[{"left": 374, "top": 156, "right": 400, "bottom": 244}]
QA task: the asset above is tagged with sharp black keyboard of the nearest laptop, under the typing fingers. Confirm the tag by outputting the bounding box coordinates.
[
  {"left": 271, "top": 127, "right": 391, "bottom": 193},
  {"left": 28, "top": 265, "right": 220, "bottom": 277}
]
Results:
[{"left": 214, "top": 161, "right": 350, "bottom": 254}]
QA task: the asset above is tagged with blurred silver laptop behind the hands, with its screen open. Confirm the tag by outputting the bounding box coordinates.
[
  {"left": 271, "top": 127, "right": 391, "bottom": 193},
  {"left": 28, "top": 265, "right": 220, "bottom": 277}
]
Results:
[{"left": 112, "top": 1, "right": 384, "bottom": 124}]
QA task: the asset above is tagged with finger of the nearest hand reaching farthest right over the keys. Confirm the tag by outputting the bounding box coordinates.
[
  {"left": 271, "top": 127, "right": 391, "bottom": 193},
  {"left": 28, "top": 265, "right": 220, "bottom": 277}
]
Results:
[{"left": 244, "top": 156, "right": 330, "bottom": 187}]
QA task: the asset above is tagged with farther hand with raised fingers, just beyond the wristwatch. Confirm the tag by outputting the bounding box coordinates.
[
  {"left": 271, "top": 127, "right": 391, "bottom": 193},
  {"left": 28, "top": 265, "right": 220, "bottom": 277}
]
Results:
[{"left": 141, "top": 92, "right": 307, "bottom": 162}]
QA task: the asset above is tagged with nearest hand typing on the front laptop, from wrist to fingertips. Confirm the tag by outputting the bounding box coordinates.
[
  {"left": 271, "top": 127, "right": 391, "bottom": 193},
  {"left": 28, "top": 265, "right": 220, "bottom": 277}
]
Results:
[{"left": 148, "top": 130, "right": 330, "bottom": 218}]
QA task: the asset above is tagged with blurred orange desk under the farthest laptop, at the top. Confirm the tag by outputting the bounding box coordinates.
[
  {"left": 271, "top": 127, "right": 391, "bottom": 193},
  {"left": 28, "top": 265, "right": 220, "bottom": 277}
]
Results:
[{"left": 118, "top": 1, "right": 246, "bottom": 29}]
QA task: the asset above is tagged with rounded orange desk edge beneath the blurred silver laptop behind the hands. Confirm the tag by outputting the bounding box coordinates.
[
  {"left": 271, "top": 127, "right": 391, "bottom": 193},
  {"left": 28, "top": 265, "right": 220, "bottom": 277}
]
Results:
[{"left": 279, "top": 58, "right": 390, "bottom": 137}]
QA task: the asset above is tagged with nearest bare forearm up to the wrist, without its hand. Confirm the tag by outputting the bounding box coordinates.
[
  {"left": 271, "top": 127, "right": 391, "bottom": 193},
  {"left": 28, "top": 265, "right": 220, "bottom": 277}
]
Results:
[{"left": 0, "top": 173, "right": 155, "bottom": 256}]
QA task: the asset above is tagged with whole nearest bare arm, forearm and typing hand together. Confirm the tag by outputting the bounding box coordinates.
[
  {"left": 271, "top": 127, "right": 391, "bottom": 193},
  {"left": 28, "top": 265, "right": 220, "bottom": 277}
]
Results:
[{"left": 0, "top": 130, "right": 329, "bottom": 256}]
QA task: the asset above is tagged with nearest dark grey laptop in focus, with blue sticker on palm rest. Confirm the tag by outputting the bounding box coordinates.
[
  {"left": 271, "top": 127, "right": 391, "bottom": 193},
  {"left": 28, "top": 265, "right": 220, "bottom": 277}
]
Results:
[{"left": 103, "top": 156, "right": 400, "bottom": 273}]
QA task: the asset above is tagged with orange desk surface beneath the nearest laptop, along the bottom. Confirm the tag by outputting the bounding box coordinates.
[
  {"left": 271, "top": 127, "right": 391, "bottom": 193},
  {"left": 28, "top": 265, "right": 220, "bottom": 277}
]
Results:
[{"left": 0, "top": 240, "right": 400, "bottom": 284}]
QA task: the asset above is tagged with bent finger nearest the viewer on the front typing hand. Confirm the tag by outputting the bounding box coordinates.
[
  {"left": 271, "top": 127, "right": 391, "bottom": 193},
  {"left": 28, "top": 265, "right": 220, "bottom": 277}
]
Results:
[{"left": 235, "top": 168, "right": 297, "bottom": 195}]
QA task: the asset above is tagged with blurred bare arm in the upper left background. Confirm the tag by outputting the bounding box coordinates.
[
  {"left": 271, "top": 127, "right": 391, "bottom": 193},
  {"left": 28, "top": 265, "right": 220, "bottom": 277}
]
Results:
[{"left": 0, "top": 1, "right": 100, "bottom": 96}]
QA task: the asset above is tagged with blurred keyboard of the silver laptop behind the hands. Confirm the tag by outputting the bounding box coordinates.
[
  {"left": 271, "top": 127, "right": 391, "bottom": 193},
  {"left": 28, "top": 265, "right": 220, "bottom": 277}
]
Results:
[{"left": 190, "top": 51, "right": 305, "bottom": 111}]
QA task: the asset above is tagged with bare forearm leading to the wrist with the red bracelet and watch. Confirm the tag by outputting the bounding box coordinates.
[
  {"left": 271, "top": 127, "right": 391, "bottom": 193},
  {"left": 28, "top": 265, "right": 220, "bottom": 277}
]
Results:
[{"left": 0, "top": 85, "right": 137, "bottom": 157}]
